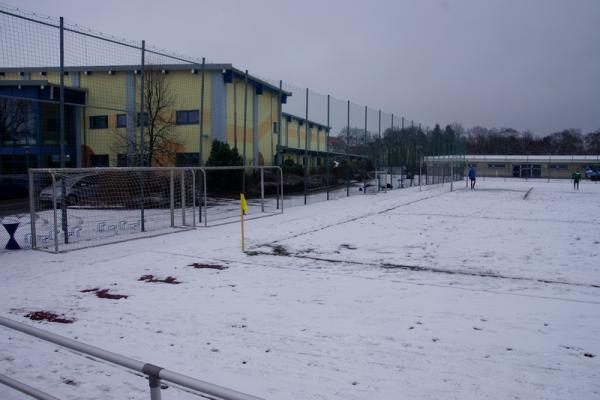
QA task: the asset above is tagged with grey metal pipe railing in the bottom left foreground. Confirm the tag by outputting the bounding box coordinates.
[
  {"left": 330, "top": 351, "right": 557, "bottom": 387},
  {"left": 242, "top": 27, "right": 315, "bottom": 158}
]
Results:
[{"left": 0, "top": 317, "right": 264, "bottom": 400}]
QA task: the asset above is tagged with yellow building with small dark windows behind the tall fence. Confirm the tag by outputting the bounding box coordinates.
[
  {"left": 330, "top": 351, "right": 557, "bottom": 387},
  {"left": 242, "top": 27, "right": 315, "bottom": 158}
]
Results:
[{"left": 0, "top": 64, "right": 327, "bottom": 167}]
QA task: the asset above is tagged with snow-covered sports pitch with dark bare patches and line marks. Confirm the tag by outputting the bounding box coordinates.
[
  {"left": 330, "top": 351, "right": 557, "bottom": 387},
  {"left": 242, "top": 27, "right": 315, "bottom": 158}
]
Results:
[{"left": 0, "top": 179, "right": 600, "bottom": 400}]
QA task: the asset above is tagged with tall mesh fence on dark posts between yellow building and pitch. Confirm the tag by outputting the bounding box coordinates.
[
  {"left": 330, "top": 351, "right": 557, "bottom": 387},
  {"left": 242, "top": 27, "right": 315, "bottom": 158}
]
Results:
[{"left": 0, "top": 6, "right": 464, "bottom": 252}]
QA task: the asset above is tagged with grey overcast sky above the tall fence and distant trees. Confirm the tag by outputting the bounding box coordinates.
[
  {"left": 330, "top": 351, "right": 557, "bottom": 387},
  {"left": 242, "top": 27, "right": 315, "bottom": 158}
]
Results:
[{"left": 14, "top": 0, "right": 600, "bottom": 134}]
